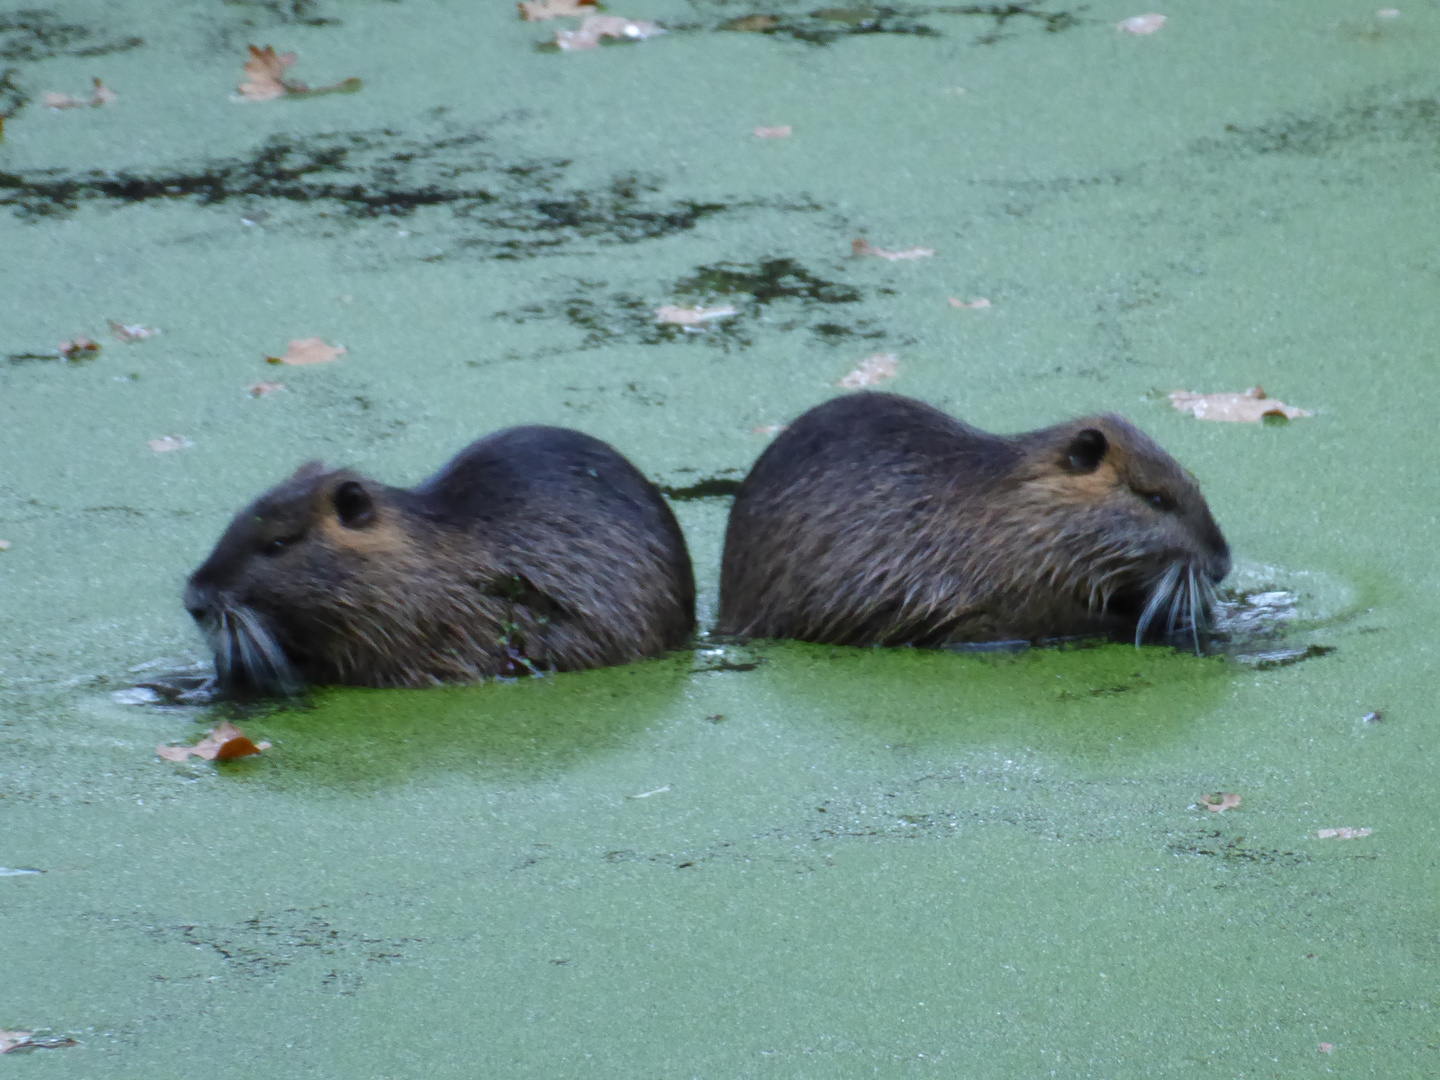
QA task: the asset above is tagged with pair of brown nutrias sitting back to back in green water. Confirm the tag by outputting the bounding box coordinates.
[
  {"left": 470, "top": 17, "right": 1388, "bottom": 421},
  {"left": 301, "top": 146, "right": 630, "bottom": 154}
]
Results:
[{"left": 186, "top": 393, "right": 1230, "bottom": 691}]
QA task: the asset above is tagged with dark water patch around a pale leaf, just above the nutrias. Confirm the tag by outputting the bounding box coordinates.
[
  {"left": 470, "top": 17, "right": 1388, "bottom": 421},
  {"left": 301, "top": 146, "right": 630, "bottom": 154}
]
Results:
[{"left": 495, "top": 258, "right": 886, "bottom": 353}]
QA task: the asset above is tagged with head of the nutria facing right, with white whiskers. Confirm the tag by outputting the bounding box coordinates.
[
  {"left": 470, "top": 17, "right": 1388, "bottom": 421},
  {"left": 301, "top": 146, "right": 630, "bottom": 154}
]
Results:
[{"left": 1012, "top": 416, "right": 1230, "bottom": 647}]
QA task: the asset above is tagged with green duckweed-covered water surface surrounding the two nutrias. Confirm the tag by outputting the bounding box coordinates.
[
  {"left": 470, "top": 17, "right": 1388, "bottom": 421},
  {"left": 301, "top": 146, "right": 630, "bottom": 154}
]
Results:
[{"left": 0, "top": 0, "right": 1440, "bottom": 1079}]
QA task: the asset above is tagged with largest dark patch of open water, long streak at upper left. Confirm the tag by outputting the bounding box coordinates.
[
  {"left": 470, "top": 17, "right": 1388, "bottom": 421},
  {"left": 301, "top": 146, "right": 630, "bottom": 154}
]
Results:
[{"left": 0, "top": 130, "right": 771, "bottom": 262}]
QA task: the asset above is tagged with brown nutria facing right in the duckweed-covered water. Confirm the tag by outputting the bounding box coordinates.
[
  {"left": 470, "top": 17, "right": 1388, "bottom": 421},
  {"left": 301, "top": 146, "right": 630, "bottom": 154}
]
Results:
[{"left": 717, "top": 393, "right": 1230, "bottom": 648}]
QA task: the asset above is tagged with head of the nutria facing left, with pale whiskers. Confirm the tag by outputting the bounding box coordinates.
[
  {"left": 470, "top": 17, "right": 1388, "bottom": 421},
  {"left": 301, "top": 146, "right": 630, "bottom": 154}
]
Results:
[{"left": 184, "top": 462, "right": 426, "bottom": 693}]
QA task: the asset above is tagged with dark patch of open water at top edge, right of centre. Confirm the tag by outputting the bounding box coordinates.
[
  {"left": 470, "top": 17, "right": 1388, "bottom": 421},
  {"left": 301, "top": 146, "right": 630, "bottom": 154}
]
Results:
[{"left": 714, "top": 4, "right": 1084, "bottom": 45}]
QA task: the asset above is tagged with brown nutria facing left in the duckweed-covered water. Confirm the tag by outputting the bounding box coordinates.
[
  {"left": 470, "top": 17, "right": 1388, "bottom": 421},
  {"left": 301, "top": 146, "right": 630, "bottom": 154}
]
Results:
[{"left": 184, "top": 428, "right": 696, "bottom": 691}]
